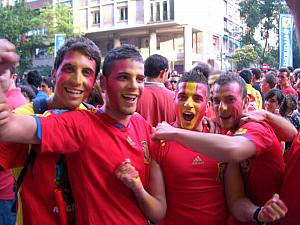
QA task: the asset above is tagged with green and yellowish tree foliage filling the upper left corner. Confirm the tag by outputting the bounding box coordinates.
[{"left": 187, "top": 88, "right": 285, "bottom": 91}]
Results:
[{"left": 0, "top": 0, "right": 82, "bottom": 73}]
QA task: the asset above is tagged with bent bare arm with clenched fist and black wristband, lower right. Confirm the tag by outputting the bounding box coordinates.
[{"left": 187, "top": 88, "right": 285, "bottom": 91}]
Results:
[{"left": 225, "top": 163, "right": 287, "bottom": 223}]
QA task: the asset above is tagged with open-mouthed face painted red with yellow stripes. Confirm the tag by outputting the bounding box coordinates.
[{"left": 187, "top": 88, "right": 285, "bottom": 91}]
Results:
[{"left": 175, "top": 82, "right": 207, "bottom": 130}]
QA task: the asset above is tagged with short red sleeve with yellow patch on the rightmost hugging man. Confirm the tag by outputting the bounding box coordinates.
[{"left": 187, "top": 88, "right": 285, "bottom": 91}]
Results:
[{"left": 234, "top": 122, "right": 277, "bottom": 156}]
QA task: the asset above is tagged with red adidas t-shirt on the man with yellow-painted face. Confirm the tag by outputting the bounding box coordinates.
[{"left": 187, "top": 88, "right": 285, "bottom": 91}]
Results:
[{"left": 152, "top": 126, "right": 228, "bottom": 225}]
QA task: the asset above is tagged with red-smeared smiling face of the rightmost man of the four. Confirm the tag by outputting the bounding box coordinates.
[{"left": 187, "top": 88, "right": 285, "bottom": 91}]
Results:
[{"left": 213, "top": 82, "right": 247, "bottom": 130}]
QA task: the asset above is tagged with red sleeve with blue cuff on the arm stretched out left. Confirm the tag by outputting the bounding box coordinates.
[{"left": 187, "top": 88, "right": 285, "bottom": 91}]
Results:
[{"left": 36, "top": 110, "right": 88, "bottom": 154}]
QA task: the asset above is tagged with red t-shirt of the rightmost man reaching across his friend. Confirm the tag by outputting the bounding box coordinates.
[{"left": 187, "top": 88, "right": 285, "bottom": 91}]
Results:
[{"left": 228, "top": 122, "right": 284, "bottom": 225}]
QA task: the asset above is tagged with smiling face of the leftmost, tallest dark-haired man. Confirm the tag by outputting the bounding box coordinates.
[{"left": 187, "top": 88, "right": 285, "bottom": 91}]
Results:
[{"left": 52, "top": 51, "right": 96, "bottom": 109}]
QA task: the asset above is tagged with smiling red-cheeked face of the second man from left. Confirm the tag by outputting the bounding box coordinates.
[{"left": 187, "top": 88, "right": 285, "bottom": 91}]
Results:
[{"left": 100, "top": 59, "right": 145, "bottom": 123}]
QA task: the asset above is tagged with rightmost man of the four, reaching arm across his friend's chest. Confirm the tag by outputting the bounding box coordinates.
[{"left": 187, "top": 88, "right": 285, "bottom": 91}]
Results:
[{"left": 154, "top": 75, "right": 294, "bottom": 224}]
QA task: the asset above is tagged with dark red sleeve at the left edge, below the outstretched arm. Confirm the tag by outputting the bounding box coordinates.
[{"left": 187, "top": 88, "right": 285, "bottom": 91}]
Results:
[{"left": 0, "top": 142, "right": 29, "bottom": 170}]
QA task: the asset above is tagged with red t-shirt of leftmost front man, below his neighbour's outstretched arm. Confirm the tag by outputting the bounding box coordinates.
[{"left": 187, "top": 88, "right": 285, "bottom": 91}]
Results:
[{"left": 0, "top": 143, "right": 75, "bottom": 225}]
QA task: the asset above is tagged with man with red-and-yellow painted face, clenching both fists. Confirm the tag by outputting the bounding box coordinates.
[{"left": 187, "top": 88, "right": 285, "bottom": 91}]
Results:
[{"left": 116, "top": 71, "right": 284, "bottom": 225}]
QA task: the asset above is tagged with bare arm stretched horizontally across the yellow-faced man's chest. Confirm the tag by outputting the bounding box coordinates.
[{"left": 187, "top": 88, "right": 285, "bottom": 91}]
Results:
[{"left": 153, "top": 122, "right": 256, "bottom": 162}]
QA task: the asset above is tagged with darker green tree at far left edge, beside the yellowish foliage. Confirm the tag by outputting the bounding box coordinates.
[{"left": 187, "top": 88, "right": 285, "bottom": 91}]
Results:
[{"left": 0, "top": 1, "right": 38, "bottom": 73}]
